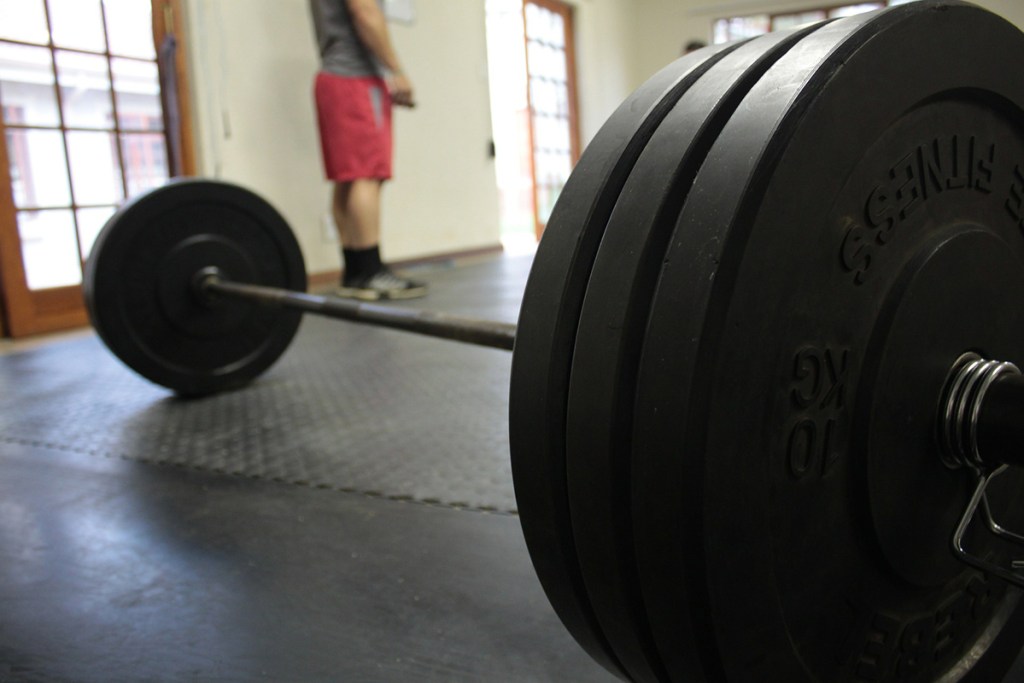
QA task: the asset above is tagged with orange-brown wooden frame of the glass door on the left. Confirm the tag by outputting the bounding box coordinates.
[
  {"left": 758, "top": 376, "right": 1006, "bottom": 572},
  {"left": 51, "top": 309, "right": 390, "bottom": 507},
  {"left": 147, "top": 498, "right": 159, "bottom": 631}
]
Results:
[{"left": 0, "top": 0, "right": 196, "bottom": 337}]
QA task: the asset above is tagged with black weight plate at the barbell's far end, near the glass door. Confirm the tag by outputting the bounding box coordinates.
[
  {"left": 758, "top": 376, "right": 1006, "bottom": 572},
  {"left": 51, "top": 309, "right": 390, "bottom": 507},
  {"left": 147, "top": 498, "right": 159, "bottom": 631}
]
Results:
[{"left": 83, "top": 179, "right": 306, "bottom": 395}]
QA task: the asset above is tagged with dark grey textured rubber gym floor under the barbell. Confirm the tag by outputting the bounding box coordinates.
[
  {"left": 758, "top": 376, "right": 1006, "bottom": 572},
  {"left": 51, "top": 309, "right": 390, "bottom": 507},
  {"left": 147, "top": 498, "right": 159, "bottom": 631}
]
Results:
[{"left": 0, "top": 252, "right": 1024, "bottom": 683}]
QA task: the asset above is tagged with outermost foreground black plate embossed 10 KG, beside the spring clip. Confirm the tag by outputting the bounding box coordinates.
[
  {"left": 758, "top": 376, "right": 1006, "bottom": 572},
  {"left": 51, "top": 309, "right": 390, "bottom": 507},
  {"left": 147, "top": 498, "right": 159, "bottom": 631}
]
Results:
[{"left": 632, "top": 1, "right": 1024, "bottom": 683}]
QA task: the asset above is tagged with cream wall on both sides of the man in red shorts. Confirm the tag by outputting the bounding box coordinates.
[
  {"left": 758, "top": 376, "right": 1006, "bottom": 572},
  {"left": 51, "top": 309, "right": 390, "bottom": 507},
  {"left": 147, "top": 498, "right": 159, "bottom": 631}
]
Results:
[{"left": 186, "top": 0, "right": 499, "bottom": 272}]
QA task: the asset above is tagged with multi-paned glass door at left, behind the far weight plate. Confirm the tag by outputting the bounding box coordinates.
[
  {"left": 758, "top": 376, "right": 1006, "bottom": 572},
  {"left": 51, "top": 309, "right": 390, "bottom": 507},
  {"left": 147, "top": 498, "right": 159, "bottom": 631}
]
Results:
[{"left": 0, "top": 0, "right": 180, "bottom": 336}]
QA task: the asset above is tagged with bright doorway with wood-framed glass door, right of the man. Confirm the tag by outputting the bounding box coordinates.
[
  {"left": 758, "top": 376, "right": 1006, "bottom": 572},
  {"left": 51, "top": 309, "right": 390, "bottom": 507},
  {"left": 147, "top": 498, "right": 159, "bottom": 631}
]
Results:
[{"left": 486, "top": 0, "right": 580, "bottom": 253}]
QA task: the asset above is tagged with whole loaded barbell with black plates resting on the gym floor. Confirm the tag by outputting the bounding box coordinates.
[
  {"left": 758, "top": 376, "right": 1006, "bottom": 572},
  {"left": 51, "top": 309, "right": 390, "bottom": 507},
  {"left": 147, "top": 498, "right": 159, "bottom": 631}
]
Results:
[{"left": 84, "top": 0, "right": 1024, "bottom": 682}]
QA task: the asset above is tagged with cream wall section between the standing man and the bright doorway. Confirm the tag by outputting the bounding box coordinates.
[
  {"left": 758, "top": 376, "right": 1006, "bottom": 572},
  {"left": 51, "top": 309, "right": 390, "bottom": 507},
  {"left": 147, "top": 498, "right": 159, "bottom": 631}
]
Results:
[{"left": 380, "top": 0, "right": 500, "bottom": 259}]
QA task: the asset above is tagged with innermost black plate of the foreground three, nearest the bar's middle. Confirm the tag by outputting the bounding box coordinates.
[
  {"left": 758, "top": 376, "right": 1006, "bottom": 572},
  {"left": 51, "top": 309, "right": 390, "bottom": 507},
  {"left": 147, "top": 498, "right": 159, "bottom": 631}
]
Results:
[{"left": 509, "top": 44, "right": 735, "bottom": 673}]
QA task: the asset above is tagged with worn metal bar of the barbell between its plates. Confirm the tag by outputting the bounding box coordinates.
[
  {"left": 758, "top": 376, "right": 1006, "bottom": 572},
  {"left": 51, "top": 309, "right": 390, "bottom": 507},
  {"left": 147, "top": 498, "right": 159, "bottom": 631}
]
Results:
[{"left": 196, "top": 269, "right": 516, "bottom": 351}]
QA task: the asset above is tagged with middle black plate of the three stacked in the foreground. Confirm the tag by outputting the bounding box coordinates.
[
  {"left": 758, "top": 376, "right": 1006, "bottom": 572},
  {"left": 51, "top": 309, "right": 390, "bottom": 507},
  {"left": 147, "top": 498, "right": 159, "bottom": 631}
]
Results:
[{"left": 565, "top": 22, "right": 827, "bottom": 681}]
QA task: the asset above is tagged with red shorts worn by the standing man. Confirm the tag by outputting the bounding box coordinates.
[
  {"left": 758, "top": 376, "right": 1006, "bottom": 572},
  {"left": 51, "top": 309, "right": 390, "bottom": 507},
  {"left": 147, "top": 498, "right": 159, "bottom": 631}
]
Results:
[{"left": 313, "top": 72, "right": 391, "bottom": 182}]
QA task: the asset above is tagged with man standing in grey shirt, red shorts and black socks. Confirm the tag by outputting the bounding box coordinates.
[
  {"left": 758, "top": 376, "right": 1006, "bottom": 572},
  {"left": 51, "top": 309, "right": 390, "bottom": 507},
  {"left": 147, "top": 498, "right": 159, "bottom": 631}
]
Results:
[{"left": 310, "top": 0, "right": 427, "bottom": 301}]
